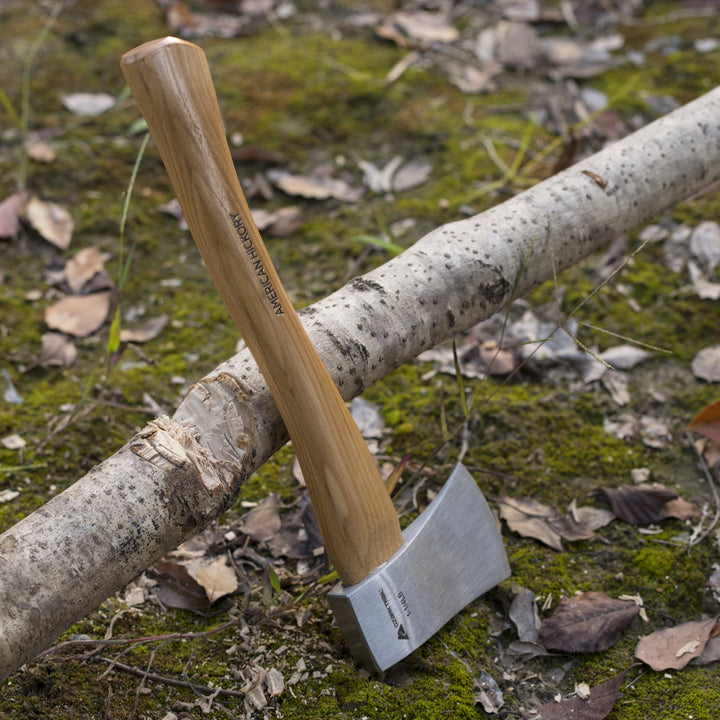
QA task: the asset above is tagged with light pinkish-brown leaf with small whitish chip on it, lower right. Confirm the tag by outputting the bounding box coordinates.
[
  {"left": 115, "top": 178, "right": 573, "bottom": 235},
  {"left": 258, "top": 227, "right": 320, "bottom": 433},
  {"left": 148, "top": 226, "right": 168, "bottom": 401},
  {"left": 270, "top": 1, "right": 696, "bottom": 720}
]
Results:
[{"left": 635, "top": 616, "right": 717, "bottom": 670}]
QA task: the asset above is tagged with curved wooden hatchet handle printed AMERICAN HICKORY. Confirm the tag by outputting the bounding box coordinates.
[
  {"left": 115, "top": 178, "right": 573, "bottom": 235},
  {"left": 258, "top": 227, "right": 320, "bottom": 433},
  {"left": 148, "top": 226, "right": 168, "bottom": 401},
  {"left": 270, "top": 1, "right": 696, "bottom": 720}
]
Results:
[{"left": 121, "top": 37, "right": 402, "bottom": 585}]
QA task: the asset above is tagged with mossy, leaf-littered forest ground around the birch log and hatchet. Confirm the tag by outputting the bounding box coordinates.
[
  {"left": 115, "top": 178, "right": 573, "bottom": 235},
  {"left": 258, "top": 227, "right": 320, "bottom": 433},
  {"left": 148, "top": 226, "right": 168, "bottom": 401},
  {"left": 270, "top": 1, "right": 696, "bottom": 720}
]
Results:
[{"left": 0, "top": 0, "right": 720, "bottom": 720}]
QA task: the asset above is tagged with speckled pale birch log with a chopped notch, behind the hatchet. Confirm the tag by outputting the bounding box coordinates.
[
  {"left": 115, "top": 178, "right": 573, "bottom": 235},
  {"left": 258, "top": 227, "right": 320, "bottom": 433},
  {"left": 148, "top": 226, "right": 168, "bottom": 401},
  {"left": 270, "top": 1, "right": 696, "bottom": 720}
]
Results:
[{"left": 0, "top": 88, "right": 720, "bottom": 679}]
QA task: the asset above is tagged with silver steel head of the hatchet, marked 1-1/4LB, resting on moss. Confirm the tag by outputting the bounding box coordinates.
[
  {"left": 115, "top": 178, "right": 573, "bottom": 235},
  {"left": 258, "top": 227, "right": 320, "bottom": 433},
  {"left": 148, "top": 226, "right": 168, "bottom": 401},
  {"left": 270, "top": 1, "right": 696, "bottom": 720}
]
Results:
[{"left": 328, "top": 464, "right": 510, "bottom": 671}]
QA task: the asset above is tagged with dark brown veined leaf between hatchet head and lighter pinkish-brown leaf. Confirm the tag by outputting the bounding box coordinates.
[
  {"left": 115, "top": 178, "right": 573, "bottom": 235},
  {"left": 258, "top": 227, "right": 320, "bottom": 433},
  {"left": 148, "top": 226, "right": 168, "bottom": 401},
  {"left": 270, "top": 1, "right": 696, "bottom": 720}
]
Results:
[{"left": 539, "top": 592, "right": 640, "bottom": 652}]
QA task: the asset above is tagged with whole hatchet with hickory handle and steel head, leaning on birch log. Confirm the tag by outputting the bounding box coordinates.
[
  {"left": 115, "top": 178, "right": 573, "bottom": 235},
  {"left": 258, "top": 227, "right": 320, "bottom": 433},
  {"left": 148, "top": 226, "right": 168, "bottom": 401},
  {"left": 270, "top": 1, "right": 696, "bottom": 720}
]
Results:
[{"left": 121, "top": 37, "right": 510, "bottom": 671}]
